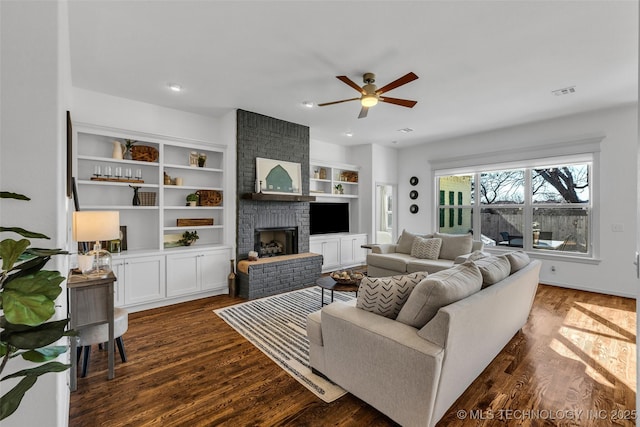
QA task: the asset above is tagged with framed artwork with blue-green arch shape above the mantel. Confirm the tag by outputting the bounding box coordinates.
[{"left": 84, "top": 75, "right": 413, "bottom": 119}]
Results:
[{"left": 256, "top": 157, "right": 302, "bottom": 194}]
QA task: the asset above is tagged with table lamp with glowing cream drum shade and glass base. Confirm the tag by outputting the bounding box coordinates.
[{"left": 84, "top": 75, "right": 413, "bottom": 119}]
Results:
[{"left": 73, "top": 211, "right": 120, "bottom": 276}]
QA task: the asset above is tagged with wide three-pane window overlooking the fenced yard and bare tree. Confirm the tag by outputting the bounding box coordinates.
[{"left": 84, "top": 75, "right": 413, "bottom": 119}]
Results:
[{"left": 436, "top": 161, "right": 593, "bottom": 255}]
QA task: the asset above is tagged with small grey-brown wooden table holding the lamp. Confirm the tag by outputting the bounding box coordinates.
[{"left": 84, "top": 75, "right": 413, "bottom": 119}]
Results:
[{"left": 67, "top": 270, "right": 116, "bottom": 391}]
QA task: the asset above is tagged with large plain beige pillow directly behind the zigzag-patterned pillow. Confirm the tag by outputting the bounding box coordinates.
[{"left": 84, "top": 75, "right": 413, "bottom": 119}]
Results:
[{"left": 396, "top": 261, "right": 482, "bottom": 329}]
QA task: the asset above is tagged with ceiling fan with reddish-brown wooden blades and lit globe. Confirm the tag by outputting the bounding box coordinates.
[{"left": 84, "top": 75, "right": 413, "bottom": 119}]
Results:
[{"left": 318, "top": 73, "right": 418, "bottom": 119}]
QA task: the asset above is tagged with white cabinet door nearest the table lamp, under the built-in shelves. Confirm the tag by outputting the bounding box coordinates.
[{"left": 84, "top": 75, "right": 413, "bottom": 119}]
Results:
[{"left": 125, "top": 255, "right": 165, "bottom": 305}]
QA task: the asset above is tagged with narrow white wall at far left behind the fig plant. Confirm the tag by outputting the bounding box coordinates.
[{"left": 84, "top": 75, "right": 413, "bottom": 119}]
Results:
[{"left": 0, "top": 1, "right": 70, "bottom": 427}]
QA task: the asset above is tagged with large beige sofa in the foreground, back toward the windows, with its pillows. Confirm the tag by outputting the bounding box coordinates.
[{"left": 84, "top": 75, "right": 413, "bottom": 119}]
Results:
[{"left": 307, "top": 252, "right": 541, "bottom": 427}]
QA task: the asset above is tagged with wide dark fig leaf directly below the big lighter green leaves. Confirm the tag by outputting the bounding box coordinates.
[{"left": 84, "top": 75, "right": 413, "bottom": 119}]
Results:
[{"left": 0, "top": 319, "right": 69, "bottom": 350}]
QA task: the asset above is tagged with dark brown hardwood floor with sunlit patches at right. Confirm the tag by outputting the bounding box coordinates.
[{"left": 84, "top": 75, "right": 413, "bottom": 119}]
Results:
[{"left": 69, "top": 285, "right": 636, "bottom": 427}]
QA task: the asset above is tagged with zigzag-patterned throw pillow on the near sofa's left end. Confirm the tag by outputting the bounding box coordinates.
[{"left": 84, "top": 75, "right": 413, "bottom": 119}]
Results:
[{"left": 356, "top": 271, "right": 427, "bottom": 319}]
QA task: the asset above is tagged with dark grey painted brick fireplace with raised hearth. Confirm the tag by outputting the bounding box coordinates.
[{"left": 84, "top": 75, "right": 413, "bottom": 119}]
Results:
[{"left": 236, "top": 110, "right": 322, "bottom": 299}]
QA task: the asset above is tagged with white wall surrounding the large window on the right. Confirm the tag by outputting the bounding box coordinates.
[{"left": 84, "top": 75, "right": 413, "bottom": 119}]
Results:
[{"left": 398, "top": 105, "right": 638, "bottom": 298}]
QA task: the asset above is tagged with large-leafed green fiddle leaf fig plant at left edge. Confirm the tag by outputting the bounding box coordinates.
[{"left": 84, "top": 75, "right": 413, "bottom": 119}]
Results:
[{"left": 0, "top": 191, "right": 75, "bottom": 420}]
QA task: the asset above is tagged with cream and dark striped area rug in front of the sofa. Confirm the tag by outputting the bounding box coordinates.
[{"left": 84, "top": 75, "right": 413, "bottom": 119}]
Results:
[{"left": 213, "top": 287, "right": 353, "bottom": 403}]
